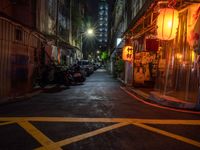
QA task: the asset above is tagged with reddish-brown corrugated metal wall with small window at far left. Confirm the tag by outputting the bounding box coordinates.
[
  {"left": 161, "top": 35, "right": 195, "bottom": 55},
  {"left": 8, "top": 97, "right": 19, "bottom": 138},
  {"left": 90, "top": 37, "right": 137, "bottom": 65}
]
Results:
[{"left": 0, "top": 17, "right": 43, "bottom": 100}]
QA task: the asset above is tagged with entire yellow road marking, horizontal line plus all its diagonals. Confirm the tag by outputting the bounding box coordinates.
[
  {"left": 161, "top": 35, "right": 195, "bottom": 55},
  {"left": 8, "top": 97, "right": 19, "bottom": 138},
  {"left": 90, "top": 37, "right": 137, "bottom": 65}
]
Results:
[{"left": 0, "top": 117, "right": 200, "bottom": 150}]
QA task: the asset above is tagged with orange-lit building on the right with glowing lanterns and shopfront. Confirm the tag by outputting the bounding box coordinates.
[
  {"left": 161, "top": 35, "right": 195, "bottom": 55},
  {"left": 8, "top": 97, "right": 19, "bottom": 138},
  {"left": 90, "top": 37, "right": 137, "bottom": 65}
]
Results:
[{"left": 109, "top": 0, "right": 200, "bottom": 108}]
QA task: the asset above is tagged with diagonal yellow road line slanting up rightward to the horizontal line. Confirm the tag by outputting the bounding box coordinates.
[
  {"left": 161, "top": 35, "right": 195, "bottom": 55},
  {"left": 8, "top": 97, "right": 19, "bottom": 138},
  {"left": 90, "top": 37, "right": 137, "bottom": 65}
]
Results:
[{"left": 37, "top": 122, "right": 130, "bottom": 150}]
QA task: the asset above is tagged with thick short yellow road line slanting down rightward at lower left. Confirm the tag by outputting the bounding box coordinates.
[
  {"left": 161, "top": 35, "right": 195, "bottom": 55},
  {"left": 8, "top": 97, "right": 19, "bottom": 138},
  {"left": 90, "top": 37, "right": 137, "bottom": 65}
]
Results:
[{"left": 17, "top": 121, "right": 62, "bottom": 150}]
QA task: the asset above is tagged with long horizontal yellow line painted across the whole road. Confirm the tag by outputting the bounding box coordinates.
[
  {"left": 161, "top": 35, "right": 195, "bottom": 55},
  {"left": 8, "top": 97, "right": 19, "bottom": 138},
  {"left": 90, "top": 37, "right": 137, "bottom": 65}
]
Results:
[{"left": 0, "top": 117, "right": 200, "bottom": 125}]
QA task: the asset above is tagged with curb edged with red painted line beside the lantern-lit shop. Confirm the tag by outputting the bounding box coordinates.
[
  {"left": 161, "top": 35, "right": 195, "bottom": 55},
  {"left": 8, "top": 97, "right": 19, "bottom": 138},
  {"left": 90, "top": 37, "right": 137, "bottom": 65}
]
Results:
[{"left": 121, "top": 86, "right": 200, "bottom": 114}]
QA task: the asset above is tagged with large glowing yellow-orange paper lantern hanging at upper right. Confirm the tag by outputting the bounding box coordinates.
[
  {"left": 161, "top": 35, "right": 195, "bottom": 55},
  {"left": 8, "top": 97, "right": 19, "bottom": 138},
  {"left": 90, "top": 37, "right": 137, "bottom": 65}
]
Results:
[{"left": 157, "top": 8, "right": 179, "bottom": 40}]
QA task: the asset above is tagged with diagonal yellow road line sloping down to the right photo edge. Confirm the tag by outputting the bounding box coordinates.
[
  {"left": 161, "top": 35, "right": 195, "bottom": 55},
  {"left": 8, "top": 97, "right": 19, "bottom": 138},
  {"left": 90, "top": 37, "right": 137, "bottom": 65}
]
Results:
[{"left": 133, "top": 123, "right": 200, "bottom": 147}]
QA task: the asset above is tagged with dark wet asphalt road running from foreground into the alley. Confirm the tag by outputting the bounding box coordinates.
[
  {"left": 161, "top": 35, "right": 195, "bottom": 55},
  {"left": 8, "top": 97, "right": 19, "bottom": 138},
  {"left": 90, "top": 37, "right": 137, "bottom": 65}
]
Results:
[{"left": 0, "top": 70, "right": 200, "bottom": 150}]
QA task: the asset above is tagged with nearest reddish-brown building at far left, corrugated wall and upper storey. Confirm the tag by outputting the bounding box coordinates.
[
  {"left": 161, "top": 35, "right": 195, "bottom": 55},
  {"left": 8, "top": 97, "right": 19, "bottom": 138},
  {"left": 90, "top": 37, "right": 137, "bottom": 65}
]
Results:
[{"left": 0, "top": 0, "right": 43, "bottom": 102}]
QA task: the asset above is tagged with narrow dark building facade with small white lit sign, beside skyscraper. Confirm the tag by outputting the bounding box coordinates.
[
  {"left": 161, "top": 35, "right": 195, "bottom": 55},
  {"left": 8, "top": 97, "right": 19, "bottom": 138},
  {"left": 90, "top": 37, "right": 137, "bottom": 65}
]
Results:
[{"left": 108, "top": 0, "right": 127, "bottom": 76}]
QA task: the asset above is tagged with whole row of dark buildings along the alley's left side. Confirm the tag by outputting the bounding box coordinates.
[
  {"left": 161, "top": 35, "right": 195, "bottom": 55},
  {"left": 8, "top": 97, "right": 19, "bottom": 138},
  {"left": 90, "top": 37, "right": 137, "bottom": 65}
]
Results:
[{"left": 0, "top": 0, "right": 82, "bottom": 103}]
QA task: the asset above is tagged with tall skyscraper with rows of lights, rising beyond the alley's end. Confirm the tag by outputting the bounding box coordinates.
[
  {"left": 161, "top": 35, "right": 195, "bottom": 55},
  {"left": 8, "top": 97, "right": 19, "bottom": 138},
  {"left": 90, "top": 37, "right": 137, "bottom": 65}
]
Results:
[{"left": 97, "top": 0, "right": 108, "bottom": 51}]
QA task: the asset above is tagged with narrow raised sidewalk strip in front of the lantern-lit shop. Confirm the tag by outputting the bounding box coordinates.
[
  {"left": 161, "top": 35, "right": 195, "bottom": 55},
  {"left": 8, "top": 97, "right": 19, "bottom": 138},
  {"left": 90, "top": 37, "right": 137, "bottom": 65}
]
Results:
[{"left": 121, "top": 86, "right": 200, "bottom": 111}]
